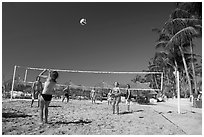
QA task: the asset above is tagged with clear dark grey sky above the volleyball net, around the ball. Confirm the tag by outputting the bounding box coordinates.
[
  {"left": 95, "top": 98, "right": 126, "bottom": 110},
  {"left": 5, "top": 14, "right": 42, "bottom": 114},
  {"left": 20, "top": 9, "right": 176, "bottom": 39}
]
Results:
[{"left": 2, "top": 2, "right": 202, "bottom": 83}]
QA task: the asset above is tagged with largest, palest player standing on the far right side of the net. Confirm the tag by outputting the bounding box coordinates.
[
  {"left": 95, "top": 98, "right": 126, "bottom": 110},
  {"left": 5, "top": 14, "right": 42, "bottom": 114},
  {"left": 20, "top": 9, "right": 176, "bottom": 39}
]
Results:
[{"left": 112, "top": 82, "right": 121, "bottom": 115}]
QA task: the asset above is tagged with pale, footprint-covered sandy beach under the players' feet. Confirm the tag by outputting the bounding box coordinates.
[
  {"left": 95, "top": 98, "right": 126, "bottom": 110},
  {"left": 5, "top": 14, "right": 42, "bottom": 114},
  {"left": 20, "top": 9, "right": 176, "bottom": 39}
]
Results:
[{"left": 2, "top": 100, "right": 202, "bottom": 135}]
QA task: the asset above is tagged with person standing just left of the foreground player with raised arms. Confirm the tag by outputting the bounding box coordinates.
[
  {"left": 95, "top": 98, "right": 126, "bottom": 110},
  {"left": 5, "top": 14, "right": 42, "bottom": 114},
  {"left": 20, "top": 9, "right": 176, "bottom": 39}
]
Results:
[{"left": 31, "top": 76, "right": 43, "bottom": 107}]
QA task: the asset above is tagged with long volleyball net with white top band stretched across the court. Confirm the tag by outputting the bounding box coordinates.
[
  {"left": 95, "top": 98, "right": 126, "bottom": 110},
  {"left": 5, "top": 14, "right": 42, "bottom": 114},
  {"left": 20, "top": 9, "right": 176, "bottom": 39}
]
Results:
[{"left": 10, "top": 66, "right": 163, "bottom": 99}]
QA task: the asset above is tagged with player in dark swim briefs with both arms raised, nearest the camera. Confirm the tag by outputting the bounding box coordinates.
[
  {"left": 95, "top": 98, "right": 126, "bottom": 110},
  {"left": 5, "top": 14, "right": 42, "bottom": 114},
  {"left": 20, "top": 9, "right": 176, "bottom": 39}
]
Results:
[{"left": 39, "top": 70, "right": 59, "bottom": 123}]
